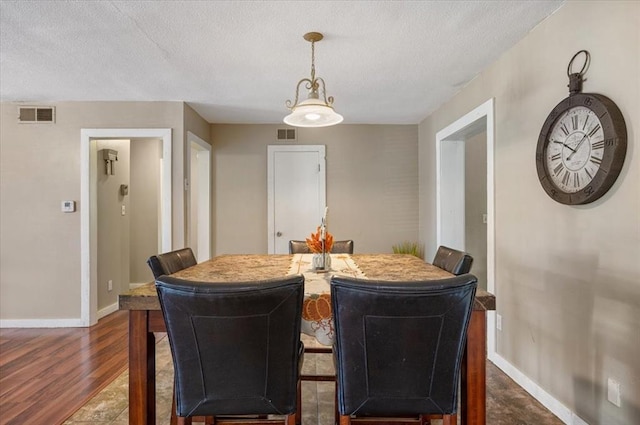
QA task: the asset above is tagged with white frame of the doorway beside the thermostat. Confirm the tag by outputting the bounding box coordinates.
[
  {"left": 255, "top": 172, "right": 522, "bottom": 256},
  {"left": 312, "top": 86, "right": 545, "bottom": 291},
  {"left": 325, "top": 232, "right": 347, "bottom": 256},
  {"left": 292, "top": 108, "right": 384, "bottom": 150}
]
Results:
[{"left": 80, "top": 128, "right": 172, "bottom": 326}]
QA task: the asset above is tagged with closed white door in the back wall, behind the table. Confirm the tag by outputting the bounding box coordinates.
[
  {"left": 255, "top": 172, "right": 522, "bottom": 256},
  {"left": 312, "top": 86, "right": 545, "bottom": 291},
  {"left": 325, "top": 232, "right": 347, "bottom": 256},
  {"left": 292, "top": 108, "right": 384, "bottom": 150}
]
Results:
[{"left": 267, "top": 145, "right": 326, "bottom": 254}]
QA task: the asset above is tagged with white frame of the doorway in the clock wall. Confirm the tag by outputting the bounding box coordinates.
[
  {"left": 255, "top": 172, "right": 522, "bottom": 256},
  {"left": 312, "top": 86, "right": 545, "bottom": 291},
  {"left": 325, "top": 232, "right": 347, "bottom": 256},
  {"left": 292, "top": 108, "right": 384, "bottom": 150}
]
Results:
[{"left": 436, "top": 98, "right": 496, "bottom": 359}]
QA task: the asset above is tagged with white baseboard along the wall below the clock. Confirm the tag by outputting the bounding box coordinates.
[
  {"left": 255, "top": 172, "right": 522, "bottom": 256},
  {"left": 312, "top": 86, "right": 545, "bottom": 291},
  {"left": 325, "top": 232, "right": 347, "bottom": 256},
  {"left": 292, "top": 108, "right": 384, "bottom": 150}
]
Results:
[{"left": 489, "top": 352, "right": 589, "bottom": 425}]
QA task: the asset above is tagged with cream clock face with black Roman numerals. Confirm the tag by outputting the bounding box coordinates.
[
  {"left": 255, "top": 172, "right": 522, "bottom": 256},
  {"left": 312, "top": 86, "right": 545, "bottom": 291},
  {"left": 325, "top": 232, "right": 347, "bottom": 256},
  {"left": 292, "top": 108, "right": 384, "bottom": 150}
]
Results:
[{"left": 545, "top": 106, "right": 604, "bottom": 193}]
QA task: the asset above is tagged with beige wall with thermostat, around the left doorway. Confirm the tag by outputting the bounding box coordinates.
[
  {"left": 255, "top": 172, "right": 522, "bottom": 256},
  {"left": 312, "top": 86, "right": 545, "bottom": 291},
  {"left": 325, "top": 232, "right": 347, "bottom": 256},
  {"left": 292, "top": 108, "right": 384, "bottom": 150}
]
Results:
[{"left": 0, "top": 102, "right": 192, "bottom": 320}]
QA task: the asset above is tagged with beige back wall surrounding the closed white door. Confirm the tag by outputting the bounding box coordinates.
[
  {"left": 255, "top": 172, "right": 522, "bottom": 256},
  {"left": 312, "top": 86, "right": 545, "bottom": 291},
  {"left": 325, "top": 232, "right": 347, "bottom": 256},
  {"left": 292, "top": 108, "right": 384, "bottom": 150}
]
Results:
[{"left": 211, "top": 124, "right": 418, "bottom": 255}]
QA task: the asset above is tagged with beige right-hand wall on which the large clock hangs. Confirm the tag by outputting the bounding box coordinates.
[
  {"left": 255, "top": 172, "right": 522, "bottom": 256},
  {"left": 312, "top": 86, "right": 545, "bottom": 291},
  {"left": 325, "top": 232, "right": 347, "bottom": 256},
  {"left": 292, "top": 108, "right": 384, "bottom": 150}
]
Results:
[{"left": 419, "top": 1, "right": 640, "bottom": 425}]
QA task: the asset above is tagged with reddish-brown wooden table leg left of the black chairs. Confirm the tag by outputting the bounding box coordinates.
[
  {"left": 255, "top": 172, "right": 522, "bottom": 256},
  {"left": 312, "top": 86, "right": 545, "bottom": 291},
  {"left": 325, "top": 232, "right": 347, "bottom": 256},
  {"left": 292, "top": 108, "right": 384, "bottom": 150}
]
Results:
[{"left": 129, "top": 310, "right": 156, "bottom": 425}]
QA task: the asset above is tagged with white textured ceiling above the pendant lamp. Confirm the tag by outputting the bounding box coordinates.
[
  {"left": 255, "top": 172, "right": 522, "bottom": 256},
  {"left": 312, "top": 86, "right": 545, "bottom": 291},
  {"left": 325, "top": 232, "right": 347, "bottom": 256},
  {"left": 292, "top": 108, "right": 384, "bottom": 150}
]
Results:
[{"left": 0, "top": 0, "right": 563, "bottom": 124}]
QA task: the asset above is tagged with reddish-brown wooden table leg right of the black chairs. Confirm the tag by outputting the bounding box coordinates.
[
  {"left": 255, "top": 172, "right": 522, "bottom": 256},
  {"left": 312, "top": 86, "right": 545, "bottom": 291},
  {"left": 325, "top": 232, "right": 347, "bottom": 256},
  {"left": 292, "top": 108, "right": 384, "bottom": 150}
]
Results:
[{"left": 460, "top": 310, "right": 487, "bottom": 425}]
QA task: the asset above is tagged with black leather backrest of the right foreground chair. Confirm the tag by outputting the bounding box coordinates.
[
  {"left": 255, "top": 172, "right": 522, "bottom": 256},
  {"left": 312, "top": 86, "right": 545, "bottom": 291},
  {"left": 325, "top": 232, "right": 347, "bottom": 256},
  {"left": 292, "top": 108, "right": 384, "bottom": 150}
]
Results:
[{"left": 331, "top": 274, "right": 477, "bottom": 416}]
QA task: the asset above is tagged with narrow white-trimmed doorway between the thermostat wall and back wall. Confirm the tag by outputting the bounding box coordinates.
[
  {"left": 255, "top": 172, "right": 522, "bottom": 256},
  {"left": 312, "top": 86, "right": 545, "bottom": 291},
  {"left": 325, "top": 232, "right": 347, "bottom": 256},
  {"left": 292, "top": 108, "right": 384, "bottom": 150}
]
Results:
[{"left": 186, "top": 131, "right": 212, "bottom": 263}]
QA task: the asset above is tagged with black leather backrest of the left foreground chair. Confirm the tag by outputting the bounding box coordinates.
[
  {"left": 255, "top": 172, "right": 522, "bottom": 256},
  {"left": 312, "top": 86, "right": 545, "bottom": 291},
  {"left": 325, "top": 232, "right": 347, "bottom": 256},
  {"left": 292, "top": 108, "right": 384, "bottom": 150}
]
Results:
[{"left": 156, "top": 275, "right": 304, "bottom": 416}]
